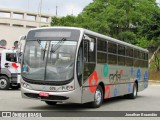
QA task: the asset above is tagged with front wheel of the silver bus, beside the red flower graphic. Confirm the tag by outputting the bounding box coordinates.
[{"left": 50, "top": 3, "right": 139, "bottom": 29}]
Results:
[{"left": 91, "top": 86, "right": 103, "bottom": 108}]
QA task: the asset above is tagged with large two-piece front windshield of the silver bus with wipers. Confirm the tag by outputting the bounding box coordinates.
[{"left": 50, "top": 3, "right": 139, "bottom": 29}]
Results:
[{"left": 22, "top": 38, "right": 77, "bottom": 82}]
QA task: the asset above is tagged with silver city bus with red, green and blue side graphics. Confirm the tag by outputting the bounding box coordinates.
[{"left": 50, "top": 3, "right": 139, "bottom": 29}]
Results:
[{"left": 21, "top": 27, "right": 148, "bottom": 107}]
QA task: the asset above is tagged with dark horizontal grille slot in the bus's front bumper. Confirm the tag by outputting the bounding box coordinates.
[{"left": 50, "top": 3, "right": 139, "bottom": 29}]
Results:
[{"left": 24, "top": 93, "right": 68, "bottom": 100}]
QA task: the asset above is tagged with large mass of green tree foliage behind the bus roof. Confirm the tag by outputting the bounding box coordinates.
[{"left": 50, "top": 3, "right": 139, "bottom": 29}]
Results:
[{"left": 51, "top": 0, "right": 160, "bottom": 48}]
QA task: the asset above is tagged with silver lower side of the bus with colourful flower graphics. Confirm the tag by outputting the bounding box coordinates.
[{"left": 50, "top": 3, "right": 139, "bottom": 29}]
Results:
[{"left": 82, "top": 64, "right": 148, "bottom": 101}]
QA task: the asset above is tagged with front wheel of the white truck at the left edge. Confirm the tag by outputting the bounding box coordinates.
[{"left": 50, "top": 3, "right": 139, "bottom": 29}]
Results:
[{"left": 0, "top": 76, "right": 10, "bottom": 90}]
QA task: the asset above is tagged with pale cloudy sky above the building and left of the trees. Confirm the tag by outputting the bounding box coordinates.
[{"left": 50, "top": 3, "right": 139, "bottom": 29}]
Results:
[{"left": 0, "top": 0, "right": 93, "bottom": 16}]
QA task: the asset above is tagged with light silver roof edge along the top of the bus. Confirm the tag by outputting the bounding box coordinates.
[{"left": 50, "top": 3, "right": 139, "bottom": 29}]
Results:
[{"left": 28, "top": 26, "right": 148, "bottom": 52}]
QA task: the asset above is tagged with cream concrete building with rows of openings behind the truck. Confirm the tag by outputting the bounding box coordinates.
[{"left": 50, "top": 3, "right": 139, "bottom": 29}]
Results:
[{"left": 0, "top": 9, "right": 52, "bottom": 49}]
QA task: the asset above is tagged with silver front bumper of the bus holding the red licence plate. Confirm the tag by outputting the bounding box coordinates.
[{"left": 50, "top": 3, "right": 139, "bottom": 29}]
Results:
[{"left": 21, "top": 87, "right": 82, "bottom": 103}]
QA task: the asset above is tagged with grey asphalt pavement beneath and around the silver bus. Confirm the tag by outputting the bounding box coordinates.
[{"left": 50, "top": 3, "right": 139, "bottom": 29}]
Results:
[{"left": 0, "top": 85, "right": 160, "bottom": 120}]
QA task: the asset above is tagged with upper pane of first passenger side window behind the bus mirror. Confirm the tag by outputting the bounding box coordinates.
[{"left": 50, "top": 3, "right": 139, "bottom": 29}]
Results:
[{"left": 97, "top": 39, "right": 107, "bottom": 52}]
